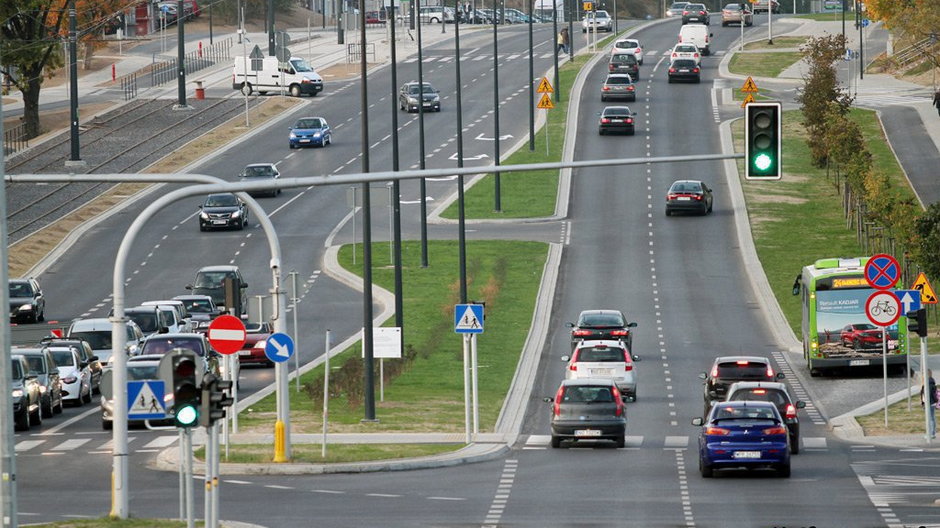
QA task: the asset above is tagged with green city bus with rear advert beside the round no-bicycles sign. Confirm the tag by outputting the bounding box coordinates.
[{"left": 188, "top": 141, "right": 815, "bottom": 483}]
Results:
[{"left": 793, "top": 257, "right": 908, "bottom": 376}]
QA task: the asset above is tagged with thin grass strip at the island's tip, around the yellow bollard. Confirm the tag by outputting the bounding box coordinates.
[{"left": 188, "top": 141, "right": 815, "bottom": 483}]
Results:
[{"left": 195, "top": 442, "right": 463, "bottom": 464}]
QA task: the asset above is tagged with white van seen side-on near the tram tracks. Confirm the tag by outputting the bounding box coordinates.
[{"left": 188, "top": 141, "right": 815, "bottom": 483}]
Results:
[{"left": 232, "top": 57, "right": 323, "bottom": 97}]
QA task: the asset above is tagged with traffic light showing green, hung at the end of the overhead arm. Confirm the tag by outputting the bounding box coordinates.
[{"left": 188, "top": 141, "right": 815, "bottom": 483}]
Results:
[{"left": 744, "top": 102, "right": 783, "bottom": 180}]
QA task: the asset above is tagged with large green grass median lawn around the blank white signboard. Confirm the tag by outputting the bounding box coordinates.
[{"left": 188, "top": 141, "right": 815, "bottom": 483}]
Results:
[{"left": 233, "top": 241, "right": 548, "bottom": 446}]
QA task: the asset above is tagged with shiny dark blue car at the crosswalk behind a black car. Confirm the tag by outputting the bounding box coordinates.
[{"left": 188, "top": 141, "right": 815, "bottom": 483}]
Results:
[{"left": 692, "top": 401, "right": 790, "bottom": 478}]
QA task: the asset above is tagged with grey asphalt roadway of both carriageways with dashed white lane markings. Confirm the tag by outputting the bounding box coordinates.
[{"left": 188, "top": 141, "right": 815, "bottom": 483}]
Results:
[{"left": 9, "top": 12, "right": 936, "bottom": 527}]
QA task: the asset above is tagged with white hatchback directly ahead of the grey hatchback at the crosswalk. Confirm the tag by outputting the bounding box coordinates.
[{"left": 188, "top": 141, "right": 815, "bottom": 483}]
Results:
[{"left": 561, "top": 340, "right": 640, "bottom": 401}]
